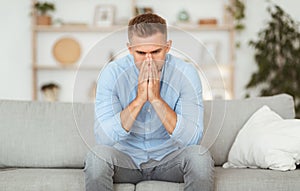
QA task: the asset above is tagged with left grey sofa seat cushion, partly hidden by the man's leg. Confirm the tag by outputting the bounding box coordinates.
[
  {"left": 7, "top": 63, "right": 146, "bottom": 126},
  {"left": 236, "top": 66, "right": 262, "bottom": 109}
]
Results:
[{"left": 0, "top": 168, "right": 135, "bottom": 191}]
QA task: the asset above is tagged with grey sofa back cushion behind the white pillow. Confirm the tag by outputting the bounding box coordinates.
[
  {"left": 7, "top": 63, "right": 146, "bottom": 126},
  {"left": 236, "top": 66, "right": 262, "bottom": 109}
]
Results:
[{"left": 201, "top": 94, "right": 295, "bottom": 165}]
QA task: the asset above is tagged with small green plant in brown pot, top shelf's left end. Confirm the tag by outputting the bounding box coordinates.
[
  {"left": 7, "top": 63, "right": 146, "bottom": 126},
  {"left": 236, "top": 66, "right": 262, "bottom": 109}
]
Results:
[{"left": 34, "top": 2, "right": 55, "bottom": 25}]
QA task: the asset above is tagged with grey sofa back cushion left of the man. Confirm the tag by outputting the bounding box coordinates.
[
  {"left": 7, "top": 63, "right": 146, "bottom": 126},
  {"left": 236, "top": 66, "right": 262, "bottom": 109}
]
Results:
[{"left": 0, "top": 100, "right": 94, "bottom": 168}]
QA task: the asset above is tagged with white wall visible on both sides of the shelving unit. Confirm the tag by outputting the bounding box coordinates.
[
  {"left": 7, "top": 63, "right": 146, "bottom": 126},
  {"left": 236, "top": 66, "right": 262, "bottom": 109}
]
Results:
[{"left": 0, "top": 0, "right": 300, "bottom": 100}]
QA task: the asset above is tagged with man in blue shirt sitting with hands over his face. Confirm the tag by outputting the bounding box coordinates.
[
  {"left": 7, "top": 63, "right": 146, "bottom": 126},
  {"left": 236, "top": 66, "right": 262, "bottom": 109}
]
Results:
[{"left": 84, "top": 13, "right": 213, "bottom": 191}]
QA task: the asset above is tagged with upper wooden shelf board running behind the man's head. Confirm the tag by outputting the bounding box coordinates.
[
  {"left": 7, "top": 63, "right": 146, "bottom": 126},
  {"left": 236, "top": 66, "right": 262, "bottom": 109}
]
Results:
[{"left": 33, "top": 25, "right": 233, "bottom": 32}]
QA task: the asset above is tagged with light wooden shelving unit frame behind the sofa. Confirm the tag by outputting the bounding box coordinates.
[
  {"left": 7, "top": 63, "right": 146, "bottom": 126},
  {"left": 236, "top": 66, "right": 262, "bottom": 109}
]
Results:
[{"left": 31, "top": 0, "right": 235, "bottom": 100}]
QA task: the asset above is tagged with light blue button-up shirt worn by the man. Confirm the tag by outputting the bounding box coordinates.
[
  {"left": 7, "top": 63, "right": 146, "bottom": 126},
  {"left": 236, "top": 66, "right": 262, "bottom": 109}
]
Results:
[{"left": 94, "top": 54, "right": 203, "bottom": 167}]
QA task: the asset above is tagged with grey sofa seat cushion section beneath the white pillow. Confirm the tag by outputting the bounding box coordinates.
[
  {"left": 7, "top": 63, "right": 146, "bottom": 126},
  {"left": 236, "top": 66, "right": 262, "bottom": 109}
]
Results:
[{"left": 215, "top": 167, "right": 300, "bottom": 191}]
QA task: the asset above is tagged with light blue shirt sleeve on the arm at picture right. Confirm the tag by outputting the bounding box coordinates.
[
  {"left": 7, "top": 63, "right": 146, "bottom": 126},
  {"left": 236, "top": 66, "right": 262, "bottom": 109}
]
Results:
[{"left": 171, "top": 66, "right": 203, "bottom": 146}]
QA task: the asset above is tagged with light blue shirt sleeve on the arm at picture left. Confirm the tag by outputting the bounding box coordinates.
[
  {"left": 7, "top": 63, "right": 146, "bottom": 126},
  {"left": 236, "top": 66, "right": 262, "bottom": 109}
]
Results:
[{"left": 94, "top": 66, "right": 129, "bottom": 145}]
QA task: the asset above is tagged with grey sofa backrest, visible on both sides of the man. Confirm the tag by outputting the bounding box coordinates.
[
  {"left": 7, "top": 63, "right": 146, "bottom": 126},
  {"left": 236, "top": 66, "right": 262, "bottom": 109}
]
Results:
[{"left": 0, "top": 94, "right": 295, "bottom": 168}]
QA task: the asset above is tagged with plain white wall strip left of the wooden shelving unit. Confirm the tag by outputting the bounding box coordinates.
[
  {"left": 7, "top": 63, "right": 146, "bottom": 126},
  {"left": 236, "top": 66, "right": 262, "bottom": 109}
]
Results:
[{"left": 0, "top": 0, "right": 32, "bottom": 99}]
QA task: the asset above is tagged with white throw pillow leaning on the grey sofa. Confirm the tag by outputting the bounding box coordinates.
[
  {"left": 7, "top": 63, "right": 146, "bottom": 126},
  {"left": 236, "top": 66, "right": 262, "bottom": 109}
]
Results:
[{"left": 223, "top": 106, "right": 300, "bottom": 171}]
